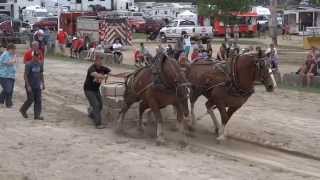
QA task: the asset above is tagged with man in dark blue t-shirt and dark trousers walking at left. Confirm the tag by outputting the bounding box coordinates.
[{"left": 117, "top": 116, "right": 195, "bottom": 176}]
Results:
[{"left": 20, "top": 51, "right": 45, "bottom": 120}]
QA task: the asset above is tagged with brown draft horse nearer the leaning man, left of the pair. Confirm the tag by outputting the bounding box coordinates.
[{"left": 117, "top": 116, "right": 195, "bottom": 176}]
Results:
[{"left": 117, "top": 55, "right": 190, "bottom": 144}]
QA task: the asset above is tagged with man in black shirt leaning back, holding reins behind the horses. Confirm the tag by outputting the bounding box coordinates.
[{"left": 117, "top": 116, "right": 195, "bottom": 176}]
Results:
[{"left": 84, "top": 56, "right": 111, "bottom": 129}]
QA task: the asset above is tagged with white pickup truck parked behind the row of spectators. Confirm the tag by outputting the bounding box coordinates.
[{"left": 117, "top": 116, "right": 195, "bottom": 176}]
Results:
[{"left": 160, "top": 20, "right": 214, "bottom": 42}]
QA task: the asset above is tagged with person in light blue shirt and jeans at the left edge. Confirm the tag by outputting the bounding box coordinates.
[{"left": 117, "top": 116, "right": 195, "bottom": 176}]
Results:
[{"left": 0, "top": 44, "right": 17, "bottom": 108}]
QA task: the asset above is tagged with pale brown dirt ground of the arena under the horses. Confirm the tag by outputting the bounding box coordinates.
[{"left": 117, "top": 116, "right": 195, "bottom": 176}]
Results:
[{"left": 0, "top": 37, "right": 320, "bottom": 180}]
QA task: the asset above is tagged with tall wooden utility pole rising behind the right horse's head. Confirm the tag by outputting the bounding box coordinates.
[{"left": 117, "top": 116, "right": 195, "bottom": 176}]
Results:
[{"left": 269, "top": 0, "right": 278, "bottom": 46}]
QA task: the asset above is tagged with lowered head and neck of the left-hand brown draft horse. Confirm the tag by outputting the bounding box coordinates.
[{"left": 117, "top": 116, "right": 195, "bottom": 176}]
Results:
[{"left": 161, "top": 56, "right": 191, "bottom": 116}]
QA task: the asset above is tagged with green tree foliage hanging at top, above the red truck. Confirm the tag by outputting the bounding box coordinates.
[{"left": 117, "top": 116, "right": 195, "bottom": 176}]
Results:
[{"left": 197, "top": 0, "right": 255, "bottom": 24}]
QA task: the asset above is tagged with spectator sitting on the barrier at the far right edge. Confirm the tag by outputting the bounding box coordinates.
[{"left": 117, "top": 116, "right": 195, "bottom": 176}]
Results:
[{"left": 298, "top": 54, "right": 317, "bottom": 87}]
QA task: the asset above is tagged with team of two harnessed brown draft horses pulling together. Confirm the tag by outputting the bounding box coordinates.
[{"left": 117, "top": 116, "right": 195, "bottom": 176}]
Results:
[{"left": 113, "top": 43, "right": 276, "bottom": 144}]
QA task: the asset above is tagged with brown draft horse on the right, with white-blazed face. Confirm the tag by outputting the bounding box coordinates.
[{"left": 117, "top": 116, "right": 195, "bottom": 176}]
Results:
[{"left": 187, "top": 52, "right": 276, "bottom": 140}]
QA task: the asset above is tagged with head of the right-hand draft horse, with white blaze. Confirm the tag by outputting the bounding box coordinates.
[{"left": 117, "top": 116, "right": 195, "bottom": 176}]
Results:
[{"left": 255, "top": 52, "right": 277, "bottom": 92}]
